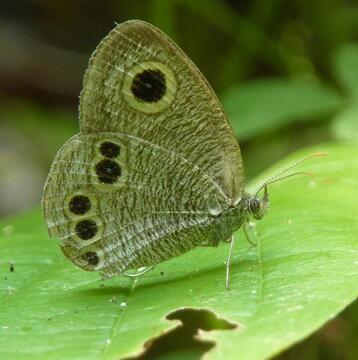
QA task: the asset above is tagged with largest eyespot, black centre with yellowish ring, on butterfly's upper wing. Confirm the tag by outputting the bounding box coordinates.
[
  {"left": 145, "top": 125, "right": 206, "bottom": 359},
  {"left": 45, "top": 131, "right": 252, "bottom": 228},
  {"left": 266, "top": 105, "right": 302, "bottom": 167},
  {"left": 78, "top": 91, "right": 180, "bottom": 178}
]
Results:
[{"left": 122, "top": 61, "right": 177, "bottom": 114}]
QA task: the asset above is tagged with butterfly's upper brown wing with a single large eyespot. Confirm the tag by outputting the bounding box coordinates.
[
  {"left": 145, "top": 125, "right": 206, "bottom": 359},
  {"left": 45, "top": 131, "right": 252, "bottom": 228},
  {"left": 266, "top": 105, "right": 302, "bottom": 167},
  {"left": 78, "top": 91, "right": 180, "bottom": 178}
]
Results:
[{"left": 80, "top": 20, "right": 244, "bottom": 204}]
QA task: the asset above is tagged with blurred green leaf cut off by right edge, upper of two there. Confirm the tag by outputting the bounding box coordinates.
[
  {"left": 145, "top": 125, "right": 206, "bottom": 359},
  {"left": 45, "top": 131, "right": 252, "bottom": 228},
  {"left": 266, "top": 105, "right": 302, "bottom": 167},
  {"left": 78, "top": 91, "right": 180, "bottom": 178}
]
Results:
[{"left": 334, "top": 43, "right": 358, "bottom": 97}]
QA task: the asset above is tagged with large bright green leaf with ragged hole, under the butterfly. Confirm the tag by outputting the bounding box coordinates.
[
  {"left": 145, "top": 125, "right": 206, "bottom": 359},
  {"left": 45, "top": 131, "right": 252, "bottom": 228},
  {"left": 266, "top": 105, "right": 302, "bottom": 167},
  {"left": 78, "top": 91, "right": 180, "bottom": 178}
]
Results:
[{"left": 0, "top": 145, "right": 358, "bottom": 360}]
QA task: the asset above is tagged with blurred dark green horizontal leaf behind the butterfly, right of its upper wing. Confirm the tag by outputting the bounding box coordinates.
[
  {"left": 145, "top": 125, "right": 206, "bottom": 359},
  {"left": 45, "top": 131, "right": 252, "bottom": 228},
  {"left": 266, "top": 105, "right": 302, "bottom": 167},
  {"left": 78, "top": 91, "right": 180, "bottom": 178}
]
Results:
[{"left": 221, "top": 79, "right": 342, "bottom": 140}]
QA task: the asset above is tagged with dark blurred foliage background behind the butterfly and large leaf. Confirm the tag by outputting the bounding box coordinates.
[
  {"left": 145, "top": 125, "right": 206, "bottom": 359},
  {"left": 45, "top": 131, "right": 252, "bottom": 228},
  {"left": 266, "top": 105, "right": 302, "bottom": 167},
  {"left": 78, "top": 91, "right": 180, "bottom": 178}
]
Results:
[{"left": 0, "top": 0, "right": 358, "bottom": 359}]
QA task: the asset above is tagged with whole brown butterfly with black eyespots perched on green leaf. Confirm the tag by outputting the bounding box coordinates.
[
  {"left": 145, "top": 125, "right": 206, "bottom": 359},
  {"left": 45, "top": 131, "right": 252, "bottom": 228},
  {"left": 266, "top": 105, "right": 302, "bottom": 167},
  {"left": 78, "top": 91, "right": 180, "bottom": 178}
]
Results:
[{"left": 42, "top": 20, "right": 322, "bottom": 286}]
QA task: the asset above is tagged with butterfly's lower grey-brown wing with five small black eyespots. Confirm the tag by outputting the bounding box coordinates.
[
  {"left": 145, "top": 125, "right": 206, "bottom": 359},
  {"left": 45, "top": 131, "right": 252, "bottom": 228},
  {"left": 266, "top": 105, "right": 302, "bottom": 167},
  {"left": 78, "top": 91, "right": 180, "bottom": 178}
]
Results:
[{"left": 43, "top": 132, "right": 223, "bottom": 277}]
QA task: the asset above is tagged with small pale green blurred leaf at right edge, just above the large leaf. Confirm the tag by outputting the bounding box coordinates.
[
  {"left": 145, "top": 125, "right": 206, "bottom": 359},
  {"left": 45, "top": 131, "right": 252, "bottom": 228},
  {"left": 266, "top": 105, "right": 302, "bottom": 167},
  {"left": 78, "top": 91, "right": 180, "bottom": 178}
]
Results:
[{"left": 333, "top": 104, "right": 358, "bottom": 142}]
